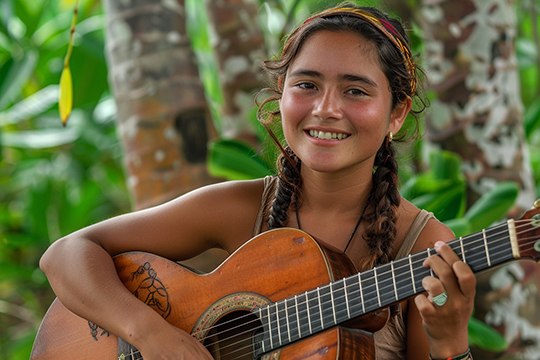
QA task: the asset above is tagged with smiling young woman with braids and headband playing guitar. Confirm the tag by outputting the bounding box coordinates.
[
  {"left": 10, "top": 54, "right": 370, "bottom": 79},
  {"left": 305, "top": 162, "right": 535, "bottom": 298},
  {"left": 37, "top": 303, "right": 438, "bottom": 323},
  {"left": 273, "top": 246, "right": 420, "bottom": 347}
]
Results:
[{"left": 41, "top": 3, "right": 476, "bottom": 359}]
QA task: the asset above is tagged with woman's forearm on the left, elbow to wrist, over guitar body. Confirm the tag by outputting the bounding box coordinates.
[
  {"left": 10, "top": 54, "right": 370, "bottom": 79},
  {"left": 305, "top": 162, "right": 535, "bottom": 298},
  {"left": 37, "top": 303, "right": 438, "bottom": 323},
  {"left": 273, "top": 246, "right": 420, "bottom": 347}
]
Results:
[{"left": 40, "top": 235, "right": 165, "bottom": 346}]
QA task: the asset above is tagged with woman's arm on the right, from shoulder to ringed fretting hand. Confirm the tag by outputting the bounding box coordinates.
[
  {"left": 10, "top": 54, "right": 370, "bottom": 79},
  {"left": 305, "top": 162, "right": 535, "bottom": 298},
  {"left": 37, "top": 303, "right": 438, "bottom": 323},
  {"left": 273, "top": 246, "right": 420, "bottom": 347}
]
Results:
[{"left": 407, "top": 219, "right": 476, "bottom": 360}]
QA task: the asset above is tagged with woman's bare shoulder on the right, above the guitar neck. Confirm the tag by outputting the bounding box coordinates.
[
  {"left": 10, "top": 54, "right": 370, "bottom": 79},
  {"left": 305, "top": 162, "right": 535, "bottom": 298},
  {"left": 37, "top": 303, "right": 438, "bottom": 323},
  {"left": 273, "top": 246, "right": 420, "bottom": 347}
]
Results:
[{"left": 402, "top": 200, "right": 455, "bottom": 254}]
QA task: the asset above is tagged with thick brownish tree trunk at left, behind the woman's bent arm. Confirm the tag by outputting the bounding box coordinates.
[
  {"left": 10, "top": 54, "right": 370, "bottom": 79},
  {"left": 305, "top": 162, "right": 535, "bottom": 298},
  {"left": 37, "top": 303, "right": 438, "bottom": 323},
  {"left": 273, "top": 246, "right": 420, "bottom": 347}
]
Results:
[{"left": 104, "top": 0, "right": 221, "bottom": 209}]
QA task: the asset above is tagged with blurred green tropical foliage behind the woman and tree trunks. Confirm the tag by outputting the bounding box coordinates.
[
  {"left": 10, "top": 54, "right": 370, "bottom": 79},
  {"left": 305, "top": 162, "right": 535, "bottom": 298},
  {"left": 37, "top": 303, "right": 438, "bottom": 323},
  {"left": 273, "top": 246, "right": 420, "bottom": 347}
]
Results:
[{"left": 0, "top": 0, "right": 540, "bottom": 360}]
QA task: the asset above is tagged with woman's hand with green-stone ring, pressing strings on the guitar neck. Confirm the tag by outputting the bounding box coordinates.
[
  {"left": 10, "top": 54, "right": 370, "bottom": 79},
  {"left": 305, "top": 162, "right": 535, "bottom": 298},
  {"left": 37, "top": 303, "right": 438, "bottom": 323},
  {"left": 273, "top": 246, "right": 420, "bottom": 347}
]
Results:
[{"left": 415, "top": 241, "right": 476, "bottom": 358}]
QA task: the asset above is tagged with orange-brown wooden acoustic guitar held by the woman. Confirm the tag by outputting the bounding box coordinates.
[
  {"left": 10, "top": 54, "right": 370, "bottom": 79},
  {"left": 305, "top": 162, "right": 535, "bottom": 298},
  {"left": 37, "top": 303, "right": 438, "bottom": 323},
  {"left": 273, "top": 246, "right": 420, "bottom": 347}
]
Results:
[{"left": 31, "top": 201, "right": 540, "bottom": 360}]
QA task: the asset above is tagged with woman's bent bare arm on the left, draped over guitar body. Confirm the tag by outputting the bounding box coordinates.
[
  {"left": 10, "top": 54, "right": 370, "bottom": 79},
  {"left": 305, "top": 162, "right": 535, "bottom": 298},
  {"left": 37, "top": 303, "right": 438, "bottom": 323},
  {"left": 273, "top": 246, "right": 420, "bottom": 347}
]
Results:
[{"left": 40, "top": 181, "right": 262, "bottom": 359}]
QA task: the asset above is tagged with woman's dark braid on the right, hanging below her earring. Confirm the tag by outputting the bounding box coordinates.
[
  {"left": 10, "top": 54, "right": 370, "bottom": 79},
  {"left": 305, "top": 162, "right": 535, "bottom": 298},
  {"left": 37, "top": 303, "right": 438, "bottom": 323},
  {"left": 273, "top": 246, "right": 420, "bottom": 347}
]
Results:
[{"left": 362, "top": 142, "right": 401, "bottom": 269}]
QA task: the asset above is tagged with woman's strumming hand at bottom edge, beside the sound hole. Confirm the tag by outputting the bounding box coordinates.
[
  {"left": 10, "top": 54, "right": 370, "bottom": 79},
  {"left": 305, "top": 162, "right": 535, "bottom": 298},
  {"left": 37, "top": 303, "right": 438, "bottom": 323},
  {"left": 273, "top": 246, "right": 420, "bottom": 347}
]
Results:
[{"left": 139, "top": 326, "right": 214, "bottom": 360}]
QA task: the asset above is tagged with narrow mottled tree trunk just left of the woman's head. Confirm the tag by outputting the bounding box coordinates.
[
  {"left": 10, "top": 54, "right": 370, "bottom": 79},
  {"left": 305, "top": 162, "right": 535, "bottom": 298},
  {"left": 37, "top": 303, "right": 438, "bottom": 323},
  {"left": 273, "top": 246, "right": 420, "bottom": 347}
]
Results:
[{"left": 206, "top": 0, "right": 266, "bottom": 145}]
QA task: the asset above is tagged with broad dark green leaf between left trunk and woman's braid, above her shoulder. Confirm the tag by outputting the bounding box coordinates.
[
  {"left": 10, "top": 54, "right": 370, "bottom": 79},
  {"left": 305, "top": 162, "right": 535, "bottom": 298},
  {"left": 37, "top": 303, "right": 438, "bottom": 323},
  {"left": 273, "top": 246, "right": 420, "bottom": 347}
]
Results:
[{"left": 207, "top": 139, "right": 272, "bottom": 180}]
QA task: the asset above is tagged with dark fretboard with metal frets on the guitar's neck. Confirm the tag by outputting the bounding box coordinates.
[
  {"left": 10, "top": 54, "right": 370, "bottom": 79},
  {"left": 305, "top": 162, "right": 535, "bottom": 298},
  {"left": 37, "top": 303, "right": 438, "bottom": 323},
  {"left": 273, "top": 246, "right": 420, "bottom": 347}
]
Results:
[{"left": 255, "top": 219, "right": 514, "bottom": 356}]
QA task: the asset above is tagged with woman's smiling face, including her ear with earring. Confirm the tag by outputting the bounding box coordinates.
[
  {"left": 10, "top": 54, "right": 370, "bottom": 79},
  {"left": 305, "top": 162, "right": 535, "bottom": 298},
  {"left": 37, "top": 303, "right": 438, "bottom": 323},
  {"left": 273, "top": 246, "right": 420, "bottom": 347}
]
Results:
[{"left": 280, "top": 30, "right": 410, "bottom": 174}]
